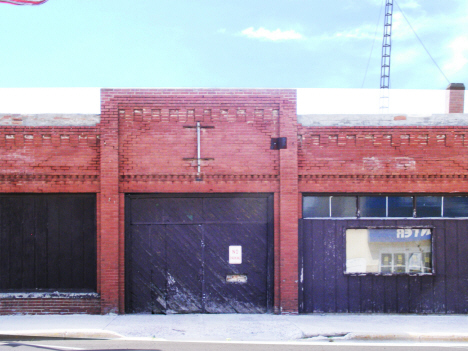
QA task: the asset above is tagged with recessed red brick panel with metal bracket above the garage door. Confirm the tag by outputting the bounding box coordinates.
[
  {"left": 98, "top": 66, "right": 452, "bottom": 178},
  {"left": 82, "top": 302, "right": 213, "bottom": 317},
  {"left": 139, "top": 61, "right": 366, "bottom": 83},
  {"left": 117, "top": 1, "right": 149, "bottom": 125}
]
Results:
[{"left": 119, "top": 104, "right": 279, "bottom": 176}]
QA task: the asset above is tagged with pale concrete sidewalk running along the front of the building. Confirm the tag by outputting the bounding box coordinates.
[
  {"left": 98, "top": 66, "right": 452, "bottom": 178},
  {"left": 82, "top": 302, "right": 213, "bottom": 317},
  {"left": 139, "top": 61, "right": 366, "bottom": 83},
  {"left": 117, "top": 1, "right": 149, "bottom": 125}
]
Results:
[{"left": 0, "top": 314, "right": 468, "bottom": 342}]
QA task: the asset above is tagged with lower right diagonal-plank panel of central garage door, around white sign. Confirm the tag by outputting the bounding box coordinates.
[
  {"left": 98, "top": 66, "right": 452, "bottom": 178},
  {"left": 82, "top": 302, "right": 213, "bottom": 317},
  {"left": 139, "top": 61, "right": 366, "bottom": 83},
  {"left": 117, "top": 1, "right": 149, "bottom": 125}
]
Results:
[{"left": 204, "top": 224, "right": 267, "bottom": 313}]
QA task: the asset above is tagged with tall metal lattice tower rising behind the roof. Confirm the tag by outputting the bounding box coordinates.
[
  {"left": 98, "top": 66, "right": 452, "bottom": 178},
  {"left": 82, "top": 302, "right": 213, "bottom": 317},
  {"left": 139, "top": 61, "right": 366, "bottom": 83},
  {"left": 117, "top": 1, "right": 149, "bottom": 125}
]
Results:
[{"left": 380, "top": 0, "right": 393, "bottom": 113}]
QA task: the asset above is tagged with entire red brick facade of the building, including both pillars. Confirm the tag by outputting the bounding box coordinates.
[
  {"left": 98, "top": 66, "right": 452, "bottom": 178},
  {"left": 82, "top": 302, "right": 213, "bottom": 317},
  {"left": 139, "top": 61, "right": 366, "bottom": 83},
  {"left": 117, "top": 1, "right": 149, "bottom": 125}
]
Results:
[{"left": 0, "top": 89, "right": 468, "bottom": 314}]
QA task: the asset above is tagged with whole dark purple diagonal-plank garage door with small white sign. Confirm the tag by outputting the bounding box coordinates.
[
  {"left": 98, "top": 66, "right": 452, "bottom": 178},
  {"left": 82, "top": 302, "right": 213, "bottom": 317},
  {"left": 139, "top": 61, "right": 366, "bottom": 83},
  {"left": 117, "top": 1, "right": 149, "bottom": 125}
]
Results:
[{"left": 125, "top": 194, "right": 273, "bottom": 313}]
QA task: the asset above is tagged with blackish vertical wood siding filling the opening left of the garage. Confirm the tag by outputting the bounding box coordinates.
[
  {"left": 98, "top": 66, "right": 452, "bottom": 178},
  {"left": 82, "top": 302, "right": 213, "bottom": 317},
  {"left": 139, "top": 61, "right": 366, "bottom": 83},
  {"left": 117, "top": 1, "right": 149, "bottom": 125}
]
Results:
[{"left": 0, "top": 194, "right": 96, "bottom": 291}]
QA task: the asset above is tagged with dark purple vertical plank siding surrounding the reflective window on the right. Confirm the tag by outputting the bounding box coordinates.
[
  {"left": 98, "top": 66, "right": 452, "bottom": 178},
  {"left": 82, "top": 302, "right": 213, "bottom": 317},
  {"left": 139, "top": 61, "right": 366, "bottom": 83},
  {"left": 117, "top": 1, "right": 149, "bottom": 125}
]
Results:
[{"left": 299, "top": 219, "right": 468, "bottom": 313}]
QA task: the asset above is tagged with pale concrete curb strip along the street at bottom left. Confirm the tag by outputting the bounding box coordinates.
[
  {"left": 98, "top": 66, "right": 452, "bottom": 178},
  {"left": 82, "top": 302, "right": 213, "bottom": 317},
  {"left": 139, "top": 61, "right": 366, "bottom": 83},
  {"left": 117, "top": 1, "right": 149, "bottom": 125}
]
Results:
[{"left": 0, "top": 330, "right": 122, "bottom": 340}]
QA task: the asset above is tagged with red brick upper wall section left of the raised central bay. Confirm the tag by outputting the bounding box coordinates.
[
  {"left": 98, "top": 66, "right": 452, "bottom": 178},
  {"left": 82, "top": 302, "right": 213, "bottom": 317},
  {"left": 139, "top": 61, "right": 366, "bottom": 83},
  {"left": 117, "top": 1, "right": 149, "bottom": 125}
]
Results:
[{"left": 0, "top": 126, "right": 99, "bottom": 193}]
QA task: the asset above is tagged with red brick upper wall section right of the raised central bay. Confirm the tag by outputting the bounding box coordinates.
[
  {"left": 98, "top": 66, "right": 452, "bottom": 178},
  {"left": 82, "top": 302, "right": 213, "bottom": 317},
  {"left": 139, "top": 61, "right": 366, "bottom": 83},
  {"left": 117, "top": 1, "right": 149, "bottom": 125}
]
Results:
[{"left": 299, "top": 127, "right": 468, "bottom": 193}]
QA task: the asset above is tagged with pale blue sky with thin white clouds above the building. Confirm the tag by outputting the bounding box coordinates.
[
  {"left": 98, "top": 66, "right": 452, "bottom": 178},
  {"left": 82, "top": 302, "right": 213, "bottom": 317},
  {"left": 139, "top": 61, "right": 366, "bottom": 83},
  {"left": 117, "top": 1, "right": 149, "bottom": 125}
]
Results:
[{"left": 0, "top": 0, "right": 468, "bottom": 89}]
